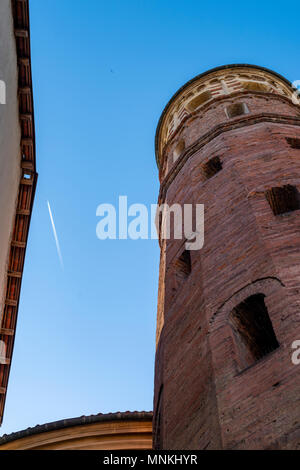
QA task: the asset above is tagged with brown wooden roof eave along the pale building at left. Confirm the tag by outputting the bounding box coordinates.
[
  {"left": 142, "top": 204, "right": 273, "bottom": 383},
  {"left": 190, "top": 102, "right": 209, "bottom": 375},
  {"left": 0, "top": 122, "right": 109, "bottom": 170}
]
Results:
[{"left": 0, "top": 0, "right": 38, "bottom": 425}]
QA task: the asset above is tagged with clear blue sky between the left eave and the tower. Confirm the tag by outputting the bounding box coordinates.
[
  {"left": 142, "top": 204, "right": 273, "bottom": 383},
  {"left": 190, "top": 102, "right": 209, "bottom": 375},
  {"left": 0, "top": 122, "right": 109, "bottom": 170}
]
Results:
[{"left": 0, "top": 0, "right": 300, "bottom": 433}]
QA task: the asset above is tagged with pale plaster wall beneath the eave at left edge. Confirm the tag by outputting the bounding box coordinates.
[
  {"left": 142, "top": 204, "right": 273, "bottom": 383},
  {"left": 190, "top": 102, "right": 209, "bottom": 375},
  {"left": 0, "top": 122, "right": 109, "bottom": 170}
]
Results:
[{"left": 0, "top": 0, "right": 21, "bottom": 321}]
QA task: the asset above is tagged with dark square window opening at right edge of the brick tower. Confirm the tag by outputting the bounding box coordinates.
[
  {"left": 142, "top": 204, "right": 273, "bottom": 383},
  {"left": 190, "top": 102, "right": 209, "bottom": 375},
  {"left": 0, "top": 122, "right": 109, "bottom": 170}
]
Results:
[{"left": 265, "top": 184, "right": 300, "bottom": 215}]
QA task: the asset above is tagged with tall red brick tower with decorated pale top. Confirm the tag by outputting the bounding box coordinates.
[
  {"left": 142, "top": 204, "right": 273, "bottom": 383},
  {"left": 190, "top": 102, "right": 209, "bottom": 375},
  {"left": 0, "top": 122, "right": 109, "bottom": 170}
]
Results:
[{"left": 154, "top": 65, "right": 300, "bottom": 449}]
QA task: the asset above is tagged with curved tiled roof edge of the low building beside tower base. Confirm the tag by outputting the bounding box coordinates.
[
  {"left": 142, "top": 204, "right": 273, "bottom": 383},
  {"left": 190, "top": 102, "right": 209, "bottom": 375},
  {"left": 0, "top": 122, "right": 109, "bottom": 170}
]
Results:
[{"left": 0, "top": 411, "right": 153, "bottom": 447}]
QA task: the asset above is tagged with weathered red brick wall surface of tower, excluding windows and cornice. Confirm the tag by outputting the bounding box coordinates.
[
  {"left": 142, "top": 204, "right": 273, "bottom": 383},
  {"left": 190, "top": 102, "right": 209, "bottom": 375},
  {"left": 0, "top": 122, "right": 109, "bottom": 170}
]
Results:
[{"left": 154, "top": 68, "right": 300, "bottom": 449}]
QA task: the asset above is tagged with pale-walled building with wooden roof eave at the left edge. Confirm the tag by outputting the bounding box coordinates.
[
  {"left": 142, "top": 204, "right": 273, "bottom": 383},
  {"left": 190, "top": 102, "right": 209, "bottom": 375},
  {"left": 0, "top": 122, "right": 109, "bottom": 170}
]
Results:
[{"left": 0, "top": 0, "right": 37, "bottom": 424}]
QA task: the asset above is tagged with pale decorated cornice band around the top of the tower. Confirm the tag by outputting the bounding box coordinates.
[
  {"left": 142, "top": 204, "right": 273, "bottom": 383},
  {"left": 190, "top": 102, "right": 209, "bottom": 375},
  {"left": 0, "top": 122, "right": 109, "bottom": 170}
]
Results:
[{"left": 155, "top": 64, "right": 295, "bottom": 167}]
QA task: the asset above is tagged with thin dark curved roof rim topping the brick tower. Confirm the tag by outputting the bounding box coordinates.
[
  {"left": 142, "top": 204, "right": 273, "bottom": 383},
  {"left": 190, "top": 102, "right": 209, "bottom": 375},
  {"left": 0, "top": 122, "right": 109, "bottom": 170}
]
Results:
[{"left": 155, "top": 64, "right": 292, "bottom": 167}]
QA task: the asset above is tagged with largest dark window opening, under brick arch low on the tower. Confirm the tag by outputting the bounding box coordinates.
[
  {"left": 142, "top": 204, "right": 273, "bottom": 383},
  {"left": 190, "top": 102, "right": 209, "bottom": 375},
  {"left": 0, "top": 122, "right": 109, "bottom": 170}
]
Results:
[{"left": 229, "top": 294, "right": 279, "bottom": 369}]
